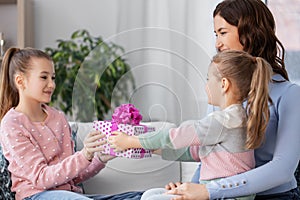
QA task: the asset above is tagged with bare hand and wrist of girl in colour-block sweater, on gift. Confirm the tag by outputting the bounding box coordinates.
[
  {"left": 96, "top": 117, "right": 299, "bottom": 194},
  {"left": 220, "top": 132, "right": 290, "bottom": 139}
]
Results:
[{"left": 108, "top": 131, "right": 143, "bottom": 151}]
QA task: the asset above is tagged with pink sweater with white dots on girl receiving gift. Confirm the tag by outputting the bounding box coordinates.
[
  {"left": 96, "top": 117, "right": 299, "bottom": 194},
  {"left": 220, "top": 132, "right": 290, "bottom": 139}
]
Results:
[{"left": 0, "top": 105, "right": 104, "bottom": 200}]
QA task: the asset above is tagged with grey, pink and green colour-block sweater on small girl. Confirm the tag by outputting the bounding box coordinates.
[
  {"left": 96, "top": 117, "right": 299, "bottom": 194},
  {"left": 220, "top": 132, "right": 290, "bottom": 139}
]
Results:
[{"left": 139, "top": 105, "right": 255, "bottom": 180}]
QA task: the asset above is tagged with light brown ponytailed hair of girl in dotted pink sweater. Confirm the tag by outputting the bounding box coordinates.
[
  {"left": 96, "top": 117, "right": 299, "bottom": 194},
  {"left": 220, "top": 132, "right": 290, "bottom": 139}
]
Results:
[{"left": 0, "top": 47, "right": 52, "bottom": 120}]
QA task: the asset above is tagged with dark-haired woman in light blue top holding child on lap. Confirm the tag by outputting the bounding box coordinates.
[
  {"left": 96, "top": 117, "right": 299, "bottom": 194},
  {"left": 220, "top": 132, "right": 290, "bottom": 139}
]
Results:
[{"left": 166, "top": 0, "right": 300, "bottom": 200}]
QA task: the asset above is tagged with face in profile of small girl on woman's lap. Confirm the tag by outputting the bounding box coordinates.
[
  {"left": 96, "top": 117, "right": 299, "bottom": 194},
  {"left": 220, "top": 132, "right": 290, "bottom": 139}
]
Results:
[{"left": 205, "top": 62, "right": 222, "bottom": 106}]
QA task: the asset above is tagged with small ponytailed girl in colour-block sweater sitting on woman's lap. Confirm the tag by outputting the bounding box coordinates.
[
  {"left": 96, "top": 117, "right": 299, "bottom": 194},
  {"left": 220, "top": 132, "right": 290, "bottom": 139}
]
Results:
[{"left": 109, "top": 50, "right": 272, "bottom": 200}]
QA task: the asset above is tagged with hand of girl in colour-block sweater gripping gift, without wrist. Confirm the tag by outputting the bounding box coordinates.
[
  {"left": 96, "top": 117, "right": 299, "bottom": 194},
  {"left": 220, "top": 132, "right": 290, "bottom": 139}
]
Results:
[{"left": 108, "top": 131, "right": 131, "bottom": 151}]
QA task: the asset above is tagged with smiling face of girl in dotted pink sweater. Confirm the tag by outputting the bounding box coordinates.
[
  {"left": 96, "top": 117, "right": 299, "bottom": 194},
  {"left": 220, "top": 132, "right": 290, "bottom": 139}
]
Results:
[{"left": 23, "top": 58, "right": 55, "bottom": 103}]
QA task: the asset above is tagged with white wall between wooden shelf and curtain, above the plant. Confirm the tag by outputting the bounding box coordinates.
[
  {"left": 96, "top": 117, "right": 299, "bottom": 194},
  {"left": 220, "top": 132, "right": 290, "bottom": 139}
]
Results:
[{"left": 33, "top": 0, "right": 118, "bottom": 49}]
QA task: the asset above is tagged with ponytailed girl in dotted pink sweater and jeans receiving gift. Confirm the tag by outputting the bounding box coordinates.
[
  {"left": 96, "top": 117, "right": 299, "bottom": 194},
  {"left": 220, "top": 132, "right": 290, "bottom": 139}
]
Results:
[{"left": 0, "top": 48, "right": 141, "bottom": 200}]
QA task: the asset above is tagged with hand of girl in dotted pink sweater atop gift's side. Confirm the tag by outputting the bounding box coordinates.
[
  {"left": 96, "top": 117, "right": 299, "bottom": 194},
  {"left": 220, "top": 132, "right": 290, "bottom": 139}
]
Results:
[{"left": 82, "top": 131, "right": 107, "bottom": 161}]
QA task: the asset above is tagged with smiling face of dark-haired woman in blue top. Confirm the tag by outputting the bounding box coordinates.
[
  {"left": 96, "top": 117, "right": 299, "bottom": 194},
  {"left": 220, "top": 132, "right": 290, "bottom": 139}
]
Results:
[{"left": 214, "top": 15, "right": 244, "bottom": 52}]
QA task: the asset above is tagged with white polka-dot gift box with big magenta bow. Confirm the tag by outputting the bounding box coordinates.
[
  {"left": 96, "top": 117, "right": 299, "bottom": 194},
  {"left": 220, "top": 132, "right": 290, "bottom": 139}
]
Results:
[{"left": 93, "top": 104, "right": 155, "bottom": 159}]
